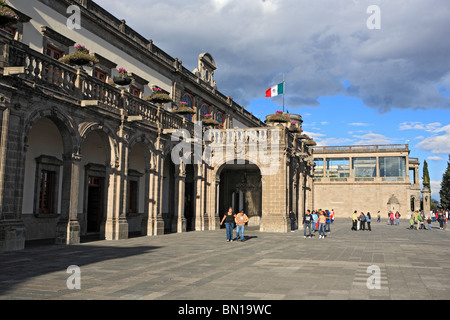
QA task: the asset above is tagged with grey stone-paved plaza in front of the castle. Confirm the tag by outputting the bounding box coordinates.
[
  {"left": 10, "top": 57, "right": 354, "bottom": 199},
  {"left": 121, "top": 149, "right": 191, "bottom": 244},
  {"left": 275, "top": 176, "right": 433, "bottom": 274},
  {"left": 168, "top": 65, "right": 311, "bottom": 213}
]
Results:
[{"left": 0, "top": 219, "right": 450, "bottom": 300}]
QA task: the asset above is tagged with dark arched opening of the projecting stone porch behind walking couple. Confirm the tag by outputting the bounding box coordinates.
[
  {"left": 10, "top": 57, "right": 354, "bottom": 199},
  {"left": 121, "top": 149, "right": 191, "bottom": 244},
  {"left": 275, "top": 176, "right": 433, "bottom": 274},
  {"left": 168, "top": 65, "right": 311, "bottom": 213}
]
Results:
[{"left": 216, "top": 161, "right": 262, "bottom": 226}]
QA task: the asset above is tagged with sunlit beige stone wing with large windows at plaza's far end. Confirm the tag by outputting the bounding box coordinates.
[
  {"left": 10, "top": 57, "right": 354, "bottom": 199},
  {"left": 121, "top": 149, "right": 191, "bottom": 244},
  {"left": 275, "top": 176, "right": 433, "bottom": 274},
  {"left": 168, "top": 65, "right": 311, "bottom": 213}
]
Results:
[{"left": 313, "top": 145, "right": 430, "bottom": 218}]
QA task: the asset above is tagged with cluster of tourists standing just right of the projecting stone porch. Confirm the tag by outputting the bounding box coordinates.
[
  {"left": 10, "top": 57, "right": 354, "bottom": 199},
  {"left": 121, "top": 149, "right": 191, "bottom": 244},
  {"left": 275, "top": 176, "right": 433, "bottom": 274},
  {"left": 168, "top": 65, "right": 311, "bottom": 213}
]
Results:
[{"left": 300, "top": 209, "right": 334, "bottom": 239}]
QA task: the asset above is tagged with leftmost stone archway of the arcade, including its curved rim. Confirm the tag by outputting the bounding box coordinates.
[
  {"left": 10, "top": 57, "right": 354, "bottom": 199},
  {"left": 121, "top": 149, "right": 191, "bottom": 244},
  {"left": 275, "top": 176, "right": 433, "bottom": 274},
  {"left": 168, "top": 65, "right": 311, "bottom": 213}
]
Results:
[{"left": 18, "top": 107, "right": 77, "bottom": 240}]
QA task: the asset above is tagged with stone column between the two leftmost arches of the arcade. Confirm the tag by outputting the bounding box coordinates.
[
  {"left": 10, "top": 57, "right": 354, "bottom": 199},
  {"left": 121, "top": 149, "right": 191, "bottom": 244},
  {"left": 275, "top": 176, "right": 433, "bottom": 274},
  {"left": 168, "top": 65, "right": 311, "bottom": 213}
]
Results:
[{"left": 55, "top": 154, "right": 81, "bottom": 245}]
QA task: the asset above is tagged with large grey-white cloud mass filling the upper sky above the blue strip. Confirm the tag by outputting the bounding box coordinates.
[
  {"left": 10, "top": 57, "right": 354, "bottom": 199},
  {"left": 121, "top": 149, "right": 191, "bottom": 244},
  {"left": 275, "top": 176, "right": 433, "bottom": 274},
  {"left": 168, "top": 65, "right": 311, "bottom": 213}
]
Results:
[{"left": 96, "top": 0, "right": 450, "bottom": 112}]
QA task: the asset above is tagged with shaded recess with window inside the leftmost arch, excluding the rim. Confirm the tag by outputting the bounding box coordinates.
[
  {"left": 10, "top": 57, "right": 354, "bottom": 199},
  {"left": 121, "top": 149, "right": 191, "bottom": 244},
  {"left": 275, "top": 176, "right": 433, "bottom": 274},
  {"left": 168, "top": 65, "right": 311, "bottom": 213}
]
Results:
[{"left": 22, "top": 117, "right": 64, "bottom": 240}]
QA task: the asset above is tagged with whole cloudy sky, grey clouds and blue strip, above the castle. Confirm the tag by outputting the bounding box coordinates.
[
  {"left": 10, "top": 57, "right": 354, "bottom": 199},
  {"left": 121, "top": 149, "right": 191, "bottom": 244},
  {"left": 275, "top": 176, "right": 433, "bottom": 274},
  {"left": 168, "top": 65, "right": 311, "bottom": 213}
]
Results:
[{"left": 95, "top": 0, "right": 450, "bottom": 199}]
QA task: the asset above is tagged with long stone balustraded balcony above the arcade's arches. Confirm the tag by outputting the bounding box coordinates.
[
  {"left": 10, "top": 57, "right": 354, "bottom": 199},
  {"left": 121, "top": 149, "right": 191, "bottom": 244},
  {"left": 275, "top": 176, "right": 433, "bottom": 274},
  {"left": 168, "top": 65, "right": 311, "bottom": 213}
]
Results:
[{"left": 0, "top": 30, "right": 194, "bottom": 132}]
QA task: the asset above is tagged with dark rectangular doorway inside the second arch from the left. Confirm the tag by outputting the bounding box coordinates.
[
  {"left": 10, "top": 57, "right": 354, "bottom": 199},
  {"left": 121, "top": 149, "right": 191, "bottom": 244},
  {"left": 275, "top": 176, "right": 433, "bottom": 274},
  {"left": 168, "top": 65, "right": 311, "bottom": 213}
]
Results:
[{"left": 87, "top": 176, "right": 104, "bottom": 232}]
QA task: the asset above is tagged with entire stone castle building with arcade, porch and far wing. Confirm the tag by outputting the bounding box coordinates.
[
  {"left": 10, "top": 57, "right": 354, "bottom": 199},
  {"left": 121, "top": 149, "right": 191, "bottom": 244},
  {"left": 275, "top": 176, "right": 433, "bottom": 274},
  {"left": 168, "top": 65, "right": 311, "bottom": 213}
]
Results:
[{"left": 0, "top": 0, "right": 428, "bottom": 252}]
